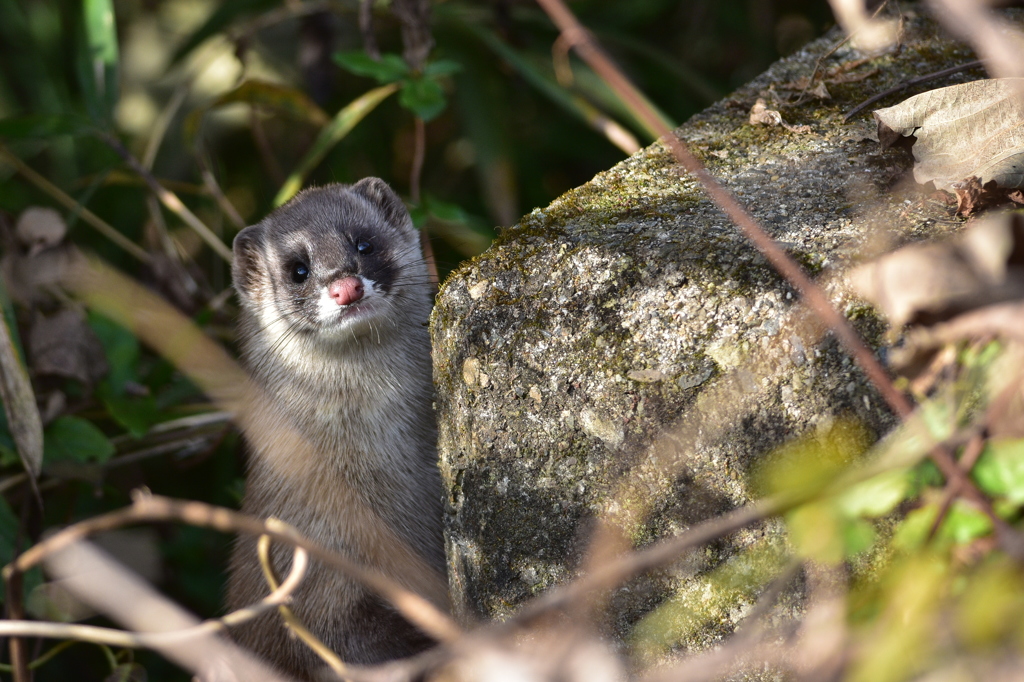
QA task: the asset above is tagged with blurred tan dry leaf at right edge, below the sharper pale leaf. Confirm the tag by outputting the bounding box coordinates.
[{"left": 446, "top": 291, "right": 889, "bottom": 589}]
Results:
[{"left": 849, "top": 213, "right": 1024, "bottom": 328}]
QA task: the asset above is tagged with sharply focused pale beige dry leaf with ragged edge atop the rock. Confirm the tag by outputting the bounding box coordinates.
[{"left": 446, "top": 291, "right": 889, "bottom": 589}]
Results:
[{"left": 873, "top": 78, "right": 1024, "bottom": 191}]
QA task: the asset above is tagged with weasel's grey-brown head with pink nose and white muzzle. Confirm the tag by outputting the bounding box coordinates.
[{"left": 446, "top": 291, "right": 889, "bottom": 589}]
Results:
[{"left": 231, "top": 178, "right": 430, "bottom": 351}]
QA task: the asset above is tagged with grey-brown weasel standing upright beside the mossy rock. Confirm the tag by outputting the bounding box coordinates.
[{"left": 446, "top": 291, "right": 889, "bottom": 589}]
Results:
[{"left": 227, "top": 178, "right": 447, "bottom": 679}]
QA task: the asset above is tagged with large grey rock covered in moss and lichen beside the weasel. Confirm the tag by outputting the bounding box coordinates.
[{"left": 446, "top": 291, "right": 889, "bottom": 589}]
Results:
[{"left": 432, "top": 7, "right": 1015, "bottom": 648}]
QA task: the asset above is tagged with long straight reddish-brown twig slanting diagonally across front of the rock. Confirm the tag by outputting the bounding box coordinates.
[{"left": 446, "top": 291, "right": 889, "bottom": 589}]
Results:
[{"left": 538, "top": 0, "right": 1024, "bottom": 556}]
